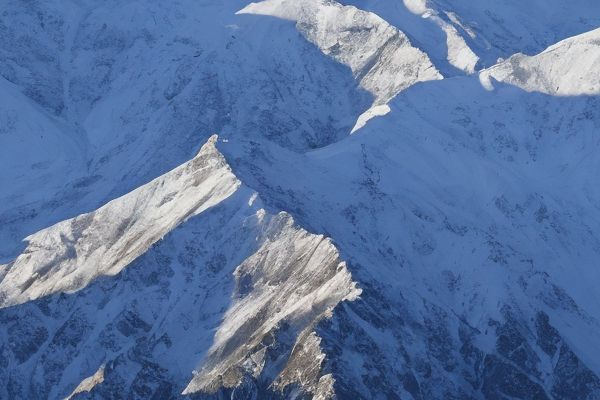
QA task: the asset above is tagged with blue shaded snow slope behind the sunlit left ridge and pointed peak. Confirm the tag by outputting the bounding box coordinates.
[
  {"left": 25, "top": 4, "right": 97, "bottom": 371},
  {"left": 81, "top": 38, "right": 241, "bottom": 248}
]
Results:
[{"left": 0, "top": 0, "right": 373, "bottom": 263}]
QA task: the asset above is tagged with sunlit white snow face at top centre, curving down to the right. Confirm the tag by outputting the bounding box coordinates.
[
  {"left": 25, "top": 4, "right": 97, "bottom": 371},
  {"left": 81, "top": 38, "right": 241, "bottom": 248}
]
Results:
[{"left": 240, "top": 0, "right": 442, "bottom": 105}]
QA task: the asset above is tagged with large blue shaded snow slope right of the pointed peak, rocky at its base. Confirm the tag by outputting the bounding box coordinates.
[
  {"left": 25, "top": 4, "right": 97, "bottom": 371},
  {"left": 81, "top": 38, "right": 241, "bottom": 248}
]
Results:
[{"left": 221, "top": 27, "right": 600, "bottom": 399}]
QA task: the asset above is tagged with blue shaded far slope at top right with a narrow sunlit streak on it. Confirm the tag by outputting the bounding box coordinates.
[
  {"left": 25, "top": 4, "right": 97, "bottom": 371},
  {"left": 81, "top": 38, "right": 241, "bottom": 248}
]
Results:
[{"left": 341, "top": 0, "right": 600, "bottom": 71}]
